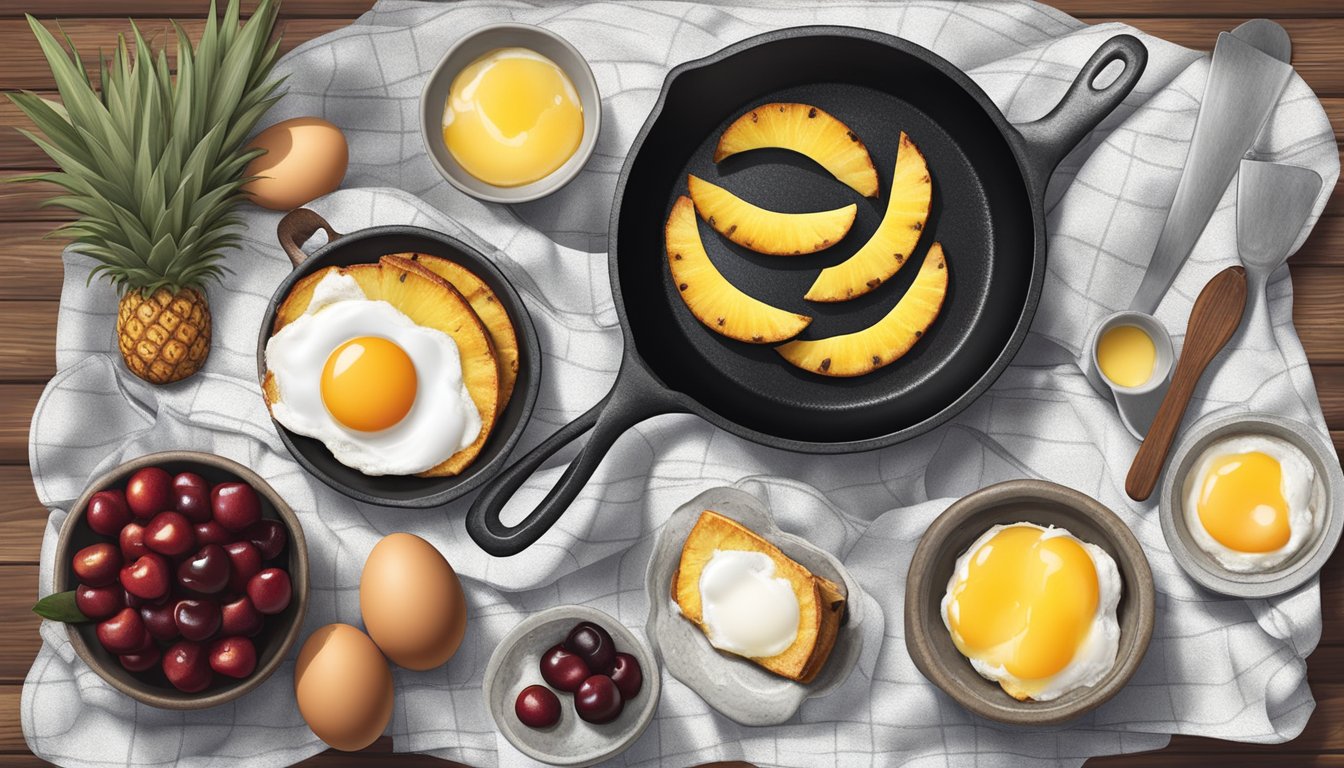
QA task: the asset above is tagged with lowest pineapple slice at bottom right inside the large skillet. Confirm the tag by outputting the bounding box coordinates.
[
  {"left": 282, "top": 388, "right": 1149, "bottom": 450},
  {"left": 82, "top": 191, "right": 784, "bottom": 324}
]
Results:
[{"left": 775, "top": 242, "right": 948, "bottom": 377}]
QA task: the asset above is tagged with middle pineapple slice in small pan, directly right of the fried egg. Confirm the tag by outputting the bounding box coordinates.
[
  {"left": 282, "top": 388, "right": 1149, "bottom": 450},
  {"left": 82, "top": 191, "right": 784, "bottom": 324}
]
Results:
[{"left": 381, "top": 256, "right": 500, "bottom": 477}]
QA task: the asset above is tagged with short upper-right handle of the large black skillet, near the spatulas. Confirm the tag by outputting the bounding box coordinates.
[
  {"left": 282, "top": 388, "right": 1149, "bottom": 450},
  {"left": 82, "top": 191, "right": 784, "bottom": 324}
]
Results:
[{"left": 1017, "top": 35, "right": 1148, "bottom": 182}]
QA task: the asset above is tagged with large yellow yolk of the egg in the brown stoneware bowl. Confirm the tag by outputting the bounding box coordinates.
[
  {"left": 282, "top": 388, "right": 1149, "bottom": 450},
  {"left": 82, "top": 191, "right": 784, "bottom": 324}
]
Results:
[{"left": 948, "top": 526, "right": 1099, "bottom": 694}]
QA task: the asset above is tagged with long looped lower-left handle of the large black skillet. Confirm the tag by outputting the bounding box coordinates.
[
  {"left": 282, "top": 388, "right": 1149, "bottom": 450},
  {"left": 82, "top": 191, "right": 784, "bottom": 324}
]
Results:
[{"left": 466, "top": 356, "right": 687, "bottom": 557}]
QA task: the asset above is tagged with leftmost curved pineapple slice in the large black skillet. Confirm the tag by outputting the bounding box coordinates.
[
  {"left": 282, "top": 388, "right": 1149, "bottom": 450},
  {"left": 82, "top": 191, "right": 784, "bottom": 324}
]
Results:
[{"left": 664, "top": 195, "right": 812, "bottom": 344}]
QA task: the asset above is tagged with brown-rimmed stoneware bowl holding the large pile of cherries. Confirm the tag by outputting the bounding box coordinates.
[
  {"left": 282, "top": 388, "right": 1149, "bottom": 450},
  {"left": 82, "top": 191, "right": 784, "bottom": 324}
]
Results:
[{"left": 55, "top": 451, "right": 308, "bottom": 709}]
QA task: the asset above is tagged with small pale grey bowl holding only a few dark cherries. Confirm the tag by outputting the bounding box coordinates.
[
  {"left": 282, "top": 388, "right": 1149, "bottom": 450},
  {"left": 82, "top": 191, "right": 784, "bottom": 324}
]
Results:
[{"left": 481, "top": 605, "right": 663, "bottom": 765}]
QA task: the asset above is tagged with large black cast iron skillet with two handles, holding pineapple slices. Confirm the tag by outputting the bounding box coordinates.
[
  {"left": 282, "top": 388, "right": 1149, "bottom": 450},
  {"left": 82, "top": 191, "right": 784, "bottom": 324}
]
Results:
[{"left": 466, "top": 27, "right": 1148, "bottom": 555}]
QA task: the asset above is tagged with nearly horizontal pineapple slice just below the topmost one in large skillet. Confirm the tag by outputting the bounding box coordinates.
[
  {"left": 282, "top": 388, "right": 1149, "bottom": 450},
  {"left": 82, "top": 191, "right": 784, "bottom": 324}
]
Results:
[{"left": 687, "top": 175, "right": 859, "bottom": 256}]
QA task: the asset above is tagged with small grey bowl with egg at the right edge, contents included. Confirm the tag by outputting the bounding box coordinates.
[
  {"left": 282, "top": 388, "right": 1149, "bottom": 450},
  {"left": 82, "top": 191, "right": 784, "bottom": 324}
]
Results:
[{"left": 1161, "top": 414, "right": 1344, "bottom": 597}]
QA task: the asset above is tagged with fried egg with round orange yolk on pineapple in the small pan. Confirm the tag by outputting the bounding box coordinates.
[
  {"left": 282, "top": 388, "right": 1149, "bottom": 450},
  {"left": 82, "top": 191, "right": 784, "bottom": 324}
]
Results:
[{"left": 266, "top": 270, "right": 481, "bottom": 475}]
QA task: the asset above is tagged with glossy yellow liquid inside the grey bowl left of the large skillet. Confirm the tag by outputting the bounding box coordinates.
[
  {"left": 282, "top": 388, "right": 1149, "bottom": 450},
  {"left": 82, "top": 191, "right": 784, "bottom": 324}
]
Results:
[{"left": 444, "top": 48, "right": 583, "bottom": 187}]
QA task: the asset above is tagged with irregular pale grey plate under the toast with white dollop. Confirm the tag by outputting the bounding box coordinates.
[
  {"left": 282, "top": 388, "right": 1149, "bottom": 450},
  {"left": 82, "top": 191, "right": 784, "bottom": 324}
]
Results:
[{"left": 644, "top": 488, "right": 864, "bottom": 725}]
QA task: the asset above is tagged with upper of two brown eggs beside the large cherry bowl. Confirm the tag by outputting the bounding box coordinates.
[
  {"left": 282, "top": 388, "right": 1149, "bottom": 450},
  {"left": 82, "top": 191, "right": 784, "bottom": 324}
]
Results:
[{"left": 359, "top": 534, "right": 466, "bottom": 670}]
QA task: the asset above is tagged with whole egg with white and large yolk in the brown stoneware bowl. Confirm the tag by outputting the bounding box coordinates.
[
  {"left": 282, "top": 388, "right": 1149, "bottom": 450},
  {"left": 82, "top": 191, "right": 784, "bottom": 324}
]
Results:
[{"left": 942, "top": 522, "right": 1121, "bottom": 701}]
